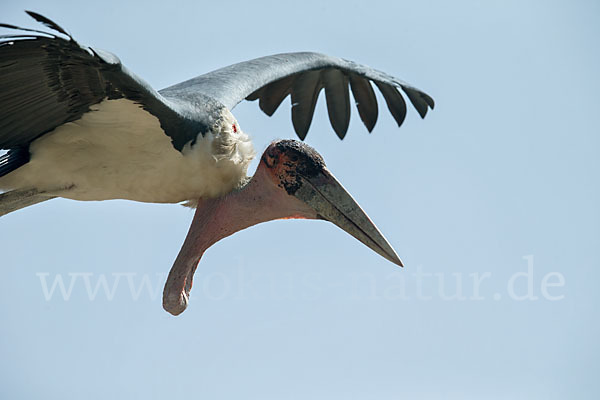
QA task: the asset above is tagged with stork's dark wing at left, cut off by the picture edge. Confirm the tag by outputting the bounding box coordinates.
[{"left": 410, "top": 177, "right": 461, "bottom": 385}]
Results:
[{"left": 0, "top": 11, "right": 202, "bottom": 155}]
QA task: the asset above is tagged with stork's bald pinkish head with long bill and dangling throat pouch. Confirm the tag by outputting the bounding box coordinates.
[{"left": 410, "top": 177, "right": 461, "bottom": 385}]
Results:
[{"left": 163, "top": 140, "right": 402, "bottom": 315}]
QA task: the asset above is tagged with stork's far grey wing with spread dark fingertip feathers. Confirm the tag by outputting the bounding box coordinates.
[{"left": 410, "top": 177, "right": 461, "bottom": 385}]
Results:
[{"left": 159, "top": 53, "right": 434, "bottom": 139}]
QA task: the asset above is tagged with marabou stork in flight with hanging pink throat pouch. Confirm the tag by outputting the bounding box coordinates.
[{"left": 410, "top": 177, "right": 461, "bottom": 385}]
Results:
[{"left": 0, "top": 11, "right": 434, "bottom": 315}]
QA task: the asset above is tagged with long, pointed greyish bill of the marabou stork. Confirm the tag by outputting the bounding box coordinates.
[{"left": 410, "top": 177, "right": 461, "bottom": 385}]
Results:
[{"left": 295, "top": 169, "right": 403, "bottom": 267}]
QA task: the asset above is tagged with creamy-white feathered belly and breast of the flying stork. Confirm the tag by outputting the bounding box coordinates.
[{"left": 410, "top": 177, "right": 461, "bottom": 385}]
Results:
[{"left": 0, "top": 99, "right": 254, "bottom": 203}]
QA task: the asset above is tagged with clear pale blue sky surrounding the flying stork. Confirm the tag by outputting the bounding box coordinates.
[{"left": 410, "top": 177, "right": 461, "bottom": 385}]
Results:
[{"left": 0, "top": 0, "right": 600, "bottom": 400}]
